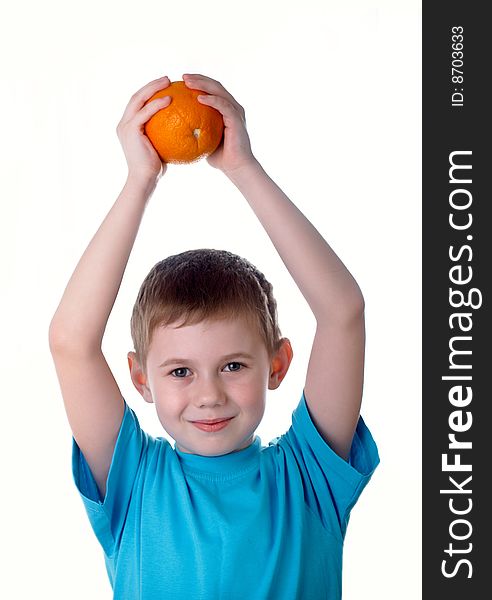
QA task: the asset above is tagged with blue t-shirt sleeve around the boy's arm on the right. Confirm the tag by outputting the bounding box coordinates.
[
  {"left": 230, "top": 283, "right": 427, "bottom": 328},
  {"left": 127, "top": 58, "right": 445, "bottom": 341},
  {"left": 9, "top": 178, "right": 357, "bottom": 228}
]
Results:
[{"left": 278, "top": 393, "right": 379, "bottom": 538}]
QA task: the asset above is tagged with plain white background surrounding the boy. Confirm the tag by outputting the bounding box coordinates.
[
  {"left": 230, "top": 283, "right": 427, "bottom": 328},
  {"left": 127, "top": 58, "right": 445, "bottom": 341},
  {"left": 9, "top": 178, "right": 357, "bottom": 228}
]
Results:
[{"left": 0, "top": 0, "right": 421, "bottom": 600}]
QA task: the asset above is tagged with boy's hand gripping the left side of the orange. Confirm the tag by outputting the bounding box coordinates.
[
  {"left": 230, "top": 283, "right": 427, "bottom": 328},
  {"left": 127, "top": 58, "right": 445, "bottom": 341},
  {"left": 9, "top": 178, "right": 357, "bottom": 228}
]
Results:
[{"left": 116, "top": 76, "right": 171, "bottom": 180}]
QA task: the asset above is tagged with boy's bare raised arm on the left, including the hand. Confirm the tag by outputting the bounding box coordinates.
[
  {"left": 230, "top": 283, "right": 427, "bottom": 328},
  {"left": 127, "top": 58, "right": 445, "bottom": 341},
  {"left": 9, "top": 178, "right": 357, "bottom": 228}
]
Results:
[{"left": 49, "top": 75, "right": 169, "bottom": 497}]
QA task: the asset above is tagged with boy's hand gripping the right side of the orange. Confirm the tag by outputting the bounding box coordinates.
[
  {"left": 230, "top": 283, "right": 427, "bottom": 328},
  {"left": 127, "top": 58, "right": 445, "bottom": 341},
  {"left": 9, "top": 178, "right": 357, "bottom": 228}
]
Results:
[{"left": 183, "top": 73, "right": 256, "bottom": 175}]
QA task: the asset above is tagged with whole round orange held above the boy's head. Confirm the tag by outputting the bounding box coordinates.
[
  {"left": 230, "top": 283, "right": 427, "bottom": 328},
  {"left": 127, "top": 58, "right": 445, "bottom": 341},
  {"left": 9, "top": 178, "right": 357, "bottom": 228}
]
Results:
[{"left": 144, "top": 81, "right": 224, "bottom": 164}]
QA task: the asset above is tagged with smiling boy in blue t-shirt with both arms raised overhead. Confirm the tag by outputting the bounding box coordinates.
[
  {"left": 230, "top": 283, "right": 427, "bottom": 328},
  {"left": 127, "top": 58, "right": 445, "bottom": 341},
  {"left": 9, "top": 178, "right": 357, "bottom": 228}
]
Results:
[{"left": 50, "top": 75, "right": 379, "bottom": 600}]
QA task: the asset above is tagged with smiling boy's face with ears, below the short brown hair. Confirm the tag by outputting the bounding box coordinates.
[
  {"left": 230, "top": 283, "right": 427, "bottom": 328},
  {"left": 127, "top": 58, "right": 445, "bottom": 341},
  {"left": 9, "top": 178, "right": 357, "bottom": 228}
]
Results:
[{"left": 129, "top": 318, "right": 292, "bottom": 456}]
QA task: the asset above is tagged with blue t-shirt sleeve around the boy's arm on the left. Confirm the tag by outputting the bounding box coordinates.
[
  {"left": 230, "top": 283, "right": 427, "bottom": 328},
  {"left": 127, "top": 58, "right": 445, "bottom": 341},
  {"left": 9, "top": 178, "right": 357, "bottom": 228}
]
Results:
[{"left": 72, "top": 401, "right": 148, "bottom": 556}]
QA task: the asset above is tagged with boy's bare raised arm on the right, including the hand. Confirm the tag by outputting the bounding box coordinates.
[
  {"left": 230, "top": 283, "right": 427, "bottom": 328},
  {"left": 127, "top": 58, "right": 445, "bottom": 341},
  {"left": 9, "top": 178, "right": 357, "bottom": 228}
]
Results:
[{"left": 184, "top": 75, "right": 365, "bottom": 459}]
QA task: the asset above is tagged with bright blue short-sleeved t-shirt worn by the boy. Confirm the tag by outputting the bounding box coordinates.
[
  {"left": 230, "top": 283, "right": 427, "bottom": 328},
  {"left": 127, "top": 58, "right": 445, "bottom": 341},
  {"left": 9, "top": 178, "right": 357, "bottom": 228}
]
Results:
[{"left": 72, "top": 394, "right": 379, "bottom": 600}]
